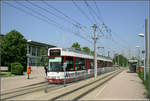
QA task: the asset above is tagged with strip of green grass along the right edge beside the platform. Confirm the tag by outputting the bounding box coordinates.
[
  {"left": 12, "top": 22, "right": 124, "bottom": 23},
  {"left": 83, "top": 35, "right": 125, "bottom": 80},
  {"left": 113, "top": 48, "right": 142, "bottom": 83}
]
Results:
[{"left": 137, "top": 69, "right": 150, "bottom": 98}]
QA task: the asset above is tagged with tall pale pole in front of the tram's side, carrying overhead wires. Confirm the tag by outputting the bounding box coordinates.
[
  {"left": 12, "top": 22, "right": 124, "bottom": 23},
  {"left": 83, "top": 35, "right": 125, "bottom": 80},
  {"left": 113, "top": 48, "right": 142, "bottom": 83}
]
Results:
[{"left": 93, "top": 24, "right": 97, "bottom": 78}]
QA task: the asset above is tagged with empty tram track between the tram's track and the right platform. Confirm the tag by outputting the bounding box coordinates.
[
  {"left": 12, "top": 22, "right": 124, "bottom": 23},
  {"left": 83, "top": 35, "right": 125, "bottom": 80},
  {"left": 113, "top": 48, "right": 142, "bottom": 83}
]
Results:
[{"left": 49, "top": 70, "right": 122, "bottom": 101}]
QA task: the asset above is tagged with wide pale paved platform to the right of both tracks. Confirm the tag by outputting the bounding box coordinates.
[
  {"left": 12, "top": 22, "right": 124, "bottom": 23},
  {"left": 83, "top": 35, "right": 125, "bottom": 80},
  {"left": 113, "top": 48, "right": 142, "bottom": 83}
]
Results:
[{"left": 81, "top": 69, "right": 146, "bottom": 100}]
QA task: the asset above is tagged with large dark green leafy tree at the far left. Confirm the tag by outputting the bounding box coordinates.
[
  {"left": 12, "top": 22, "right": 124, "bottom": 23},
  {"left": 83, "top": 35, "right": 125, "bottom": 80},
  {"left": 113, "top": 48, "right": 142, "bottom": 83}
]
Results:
[{"left": 0, "top": 30, "right": 27, "bottom": 71}]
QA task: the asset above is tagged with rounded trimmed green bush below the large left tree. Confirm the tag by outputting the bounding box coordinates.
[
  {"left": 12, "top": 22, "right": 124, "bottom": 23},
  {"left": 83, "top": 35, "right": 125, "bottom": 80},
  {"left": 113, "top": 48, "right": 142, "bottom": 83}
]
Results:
[{"left": 11, "top": 62, "right": 23, "bottom": 75}]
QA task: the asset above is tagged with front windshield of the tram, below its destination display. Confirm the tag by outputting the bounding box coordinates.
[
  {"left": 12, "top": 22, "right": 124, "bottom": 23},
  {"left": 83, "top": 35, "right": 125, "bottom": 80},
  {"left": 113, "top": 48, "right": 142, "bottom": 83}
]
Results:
[{"left": 48, "top": 57, "right": 63, "bottom": 71}]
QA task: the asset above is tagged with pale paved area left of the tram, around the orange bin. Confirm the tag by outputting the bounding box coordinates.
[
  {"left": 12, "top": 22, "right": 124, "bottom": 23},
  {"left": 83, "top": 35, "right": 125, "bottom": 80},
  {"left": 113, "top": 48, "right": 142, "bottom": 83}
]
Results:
[{"left": 0, "top": 67, "right": 46, "bottom": 92}]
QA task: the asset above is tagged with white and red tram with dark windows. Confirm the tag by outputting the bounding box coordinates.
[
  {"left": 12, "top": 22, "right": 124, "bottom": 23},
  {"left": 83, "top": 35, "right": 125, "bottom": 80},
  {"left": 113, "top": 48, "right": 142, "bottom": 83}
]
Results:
[{"left": 47, "top": 48, "right": 113, "bottom": 83}]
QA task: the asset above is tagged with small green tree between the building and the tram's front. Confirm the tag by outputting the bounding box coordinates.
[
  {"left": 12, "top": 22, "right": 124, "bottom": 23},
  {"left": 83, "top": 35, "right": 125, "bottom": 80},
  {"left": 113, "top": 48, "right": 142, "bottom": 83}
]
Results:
[{"left": 38, "top": 47, "right": 48, "bottom": 66}]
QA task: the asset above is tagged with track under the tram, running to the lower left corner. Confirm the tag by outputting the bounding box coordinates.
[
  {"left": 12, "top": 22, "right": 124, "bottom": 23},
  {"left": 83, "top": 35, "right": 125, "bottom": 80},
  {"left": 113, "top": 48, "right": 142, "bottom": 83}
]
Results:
[{"left": 0, "top": 78, "right": 81, "bottom": 100}]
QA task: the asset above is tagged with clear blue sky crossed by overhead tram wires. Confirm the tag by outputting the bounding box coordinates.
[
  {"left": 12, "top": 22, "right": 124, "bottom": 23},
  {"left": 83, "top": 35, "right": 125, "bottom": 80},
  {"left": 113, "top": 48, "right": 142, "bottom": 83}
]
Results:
[{"left": 1, "top": 1, "right": 149, "bottom": 56}]
